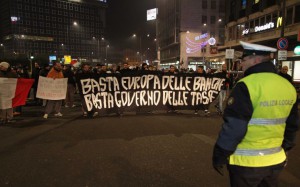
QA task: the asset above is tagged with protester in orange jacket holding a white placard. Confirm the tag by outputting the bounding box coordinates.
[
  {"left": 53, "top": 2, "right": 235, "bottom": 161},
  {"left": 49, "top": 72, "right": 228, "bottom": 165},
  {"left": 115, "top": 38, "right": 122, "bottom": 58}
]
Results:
[{"left": 43, "top": 62, "right": 64, "bottom": 119}]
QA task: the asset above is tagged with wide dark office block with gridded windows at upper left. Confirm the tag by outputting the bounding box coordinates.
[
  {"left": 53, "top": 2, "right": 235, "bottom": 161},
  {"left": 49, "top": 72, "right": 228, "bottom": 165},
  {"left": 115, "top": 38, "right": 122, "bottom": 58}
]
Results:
[{"left": 0, "top": 0, "right": 107, "bottom": 60}]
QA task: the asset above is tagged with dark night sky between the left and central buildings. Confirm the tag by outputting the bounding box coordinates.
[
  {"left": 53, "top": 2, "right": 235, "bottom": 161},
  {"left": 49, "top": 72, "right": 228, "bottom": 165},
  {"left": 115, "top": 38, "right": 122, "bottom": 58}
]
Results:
[{"left": 106, "top": 0, "right": 155, "bottom": 48}]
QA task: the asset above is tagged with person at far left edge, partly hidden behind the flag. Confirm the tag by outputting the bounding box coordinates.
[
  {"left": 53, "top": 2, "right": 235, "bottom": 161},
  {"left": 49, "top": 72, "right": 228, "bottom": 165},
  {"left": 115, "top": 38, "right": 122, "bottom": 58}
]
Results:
[{"left": 0, "top": 62, "right": 18, "bottom": 124}]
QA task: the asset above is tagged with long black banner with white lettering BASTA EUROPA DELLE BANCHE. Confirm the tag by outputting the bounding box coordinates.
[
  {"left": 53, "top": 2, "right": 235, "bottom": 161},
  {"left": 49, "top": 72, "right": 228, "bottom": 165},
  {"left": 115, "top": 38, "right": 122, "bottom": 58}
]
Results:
[{"left": 79, "top": 74, "right": 225, "bottom": 111}]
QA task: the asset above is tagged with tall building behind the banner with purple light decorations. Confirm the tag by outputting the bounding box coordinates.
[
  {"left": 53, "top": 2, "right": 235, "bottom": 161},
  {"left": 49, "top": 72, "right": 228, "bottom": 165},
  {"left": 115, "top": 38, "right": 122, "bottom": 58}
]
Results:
[{"left": 156, "top": 0, "right": 225, "bottom": 69}]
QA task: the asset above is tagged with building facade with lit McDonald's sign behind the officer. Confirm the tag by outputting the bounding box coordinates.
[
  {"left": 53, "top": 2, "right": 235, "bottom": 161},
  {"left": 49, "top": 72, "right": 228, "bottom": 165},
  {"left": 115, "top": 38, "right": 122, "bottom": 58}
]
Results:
[{"left": 225, "top": 0, "right": 300, "bottom": 82}]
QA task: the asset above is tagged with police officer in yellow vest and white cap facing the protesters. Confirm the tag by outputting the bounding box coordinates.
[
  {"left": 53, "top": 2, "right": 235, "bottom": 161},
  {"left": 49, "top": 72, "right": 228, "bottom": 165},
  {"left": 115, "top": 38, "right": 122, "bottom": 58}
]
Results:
[{"left": 212, "top": 42, "right": 299, "bottom": 186}]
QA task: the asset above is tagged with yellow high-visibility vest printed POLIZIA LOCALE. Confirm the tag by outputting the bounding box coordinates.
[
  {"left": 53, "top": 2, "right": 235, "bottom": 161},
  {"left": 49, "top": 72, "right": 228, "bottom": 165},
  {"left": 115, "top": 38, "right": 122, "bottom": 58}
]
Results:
[{"left": 229, "top": 73, "right": 297, "bottom": 167}]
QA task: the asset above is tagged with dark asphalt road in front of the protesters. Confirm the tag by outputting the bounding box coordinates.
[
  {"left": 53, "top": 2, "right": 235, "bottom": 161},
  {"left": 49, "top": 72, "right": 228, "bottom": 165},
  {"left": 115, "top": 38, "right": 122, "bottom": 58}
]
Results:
[{"left": 0, "top": 106, "right": 300, "bottom": 187}]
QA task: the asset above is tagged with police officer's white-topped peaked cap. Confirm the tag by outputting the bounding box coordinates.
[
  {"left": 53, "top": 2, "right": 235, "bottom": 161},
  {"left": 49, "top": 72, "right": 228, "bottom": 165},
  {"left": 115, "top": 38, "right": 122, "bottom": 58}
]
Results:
[{"left": 240, "top": 41, "right": 277, "bottom": 58}]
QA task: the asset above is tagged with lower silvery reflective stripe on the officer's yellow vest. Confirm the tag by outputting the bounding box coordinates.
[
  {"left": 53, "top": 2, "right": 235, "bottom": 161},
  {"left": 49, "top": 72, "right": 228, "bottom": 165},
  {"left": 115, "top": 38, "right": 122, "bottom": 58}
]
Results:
[{"left": 233, "top": 147, "right": 282, "bottom": 156}]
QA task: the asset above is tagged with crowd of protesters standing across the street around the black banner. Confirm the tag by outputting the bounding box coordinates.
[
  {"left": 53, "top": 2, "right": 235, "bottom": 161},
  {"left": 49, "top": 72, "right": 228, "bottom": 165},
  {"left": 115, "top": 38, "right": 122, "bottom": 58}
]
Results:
[{"left": 0, "top": 62, "right": 296, "bottom": 123}]
